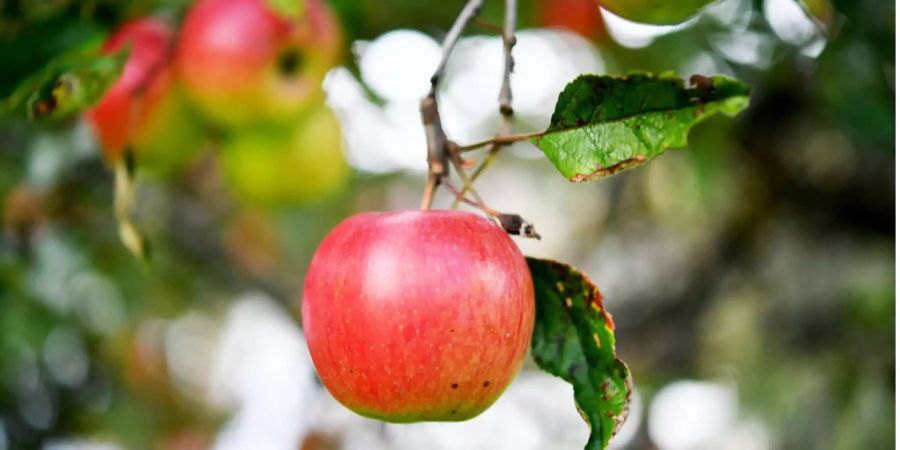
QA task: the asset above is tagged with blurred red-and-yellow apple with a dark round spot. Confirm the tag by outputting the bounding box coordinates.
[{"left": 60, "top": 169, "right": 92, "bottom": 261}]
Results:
[{"left": 176, "top": 0, "right": 341, "bottom": 127}]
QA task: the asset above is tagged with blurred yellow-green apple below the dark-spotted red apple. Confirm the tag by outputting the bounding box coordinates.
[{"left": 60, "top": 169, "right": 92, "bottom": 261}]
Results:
[{"left": 220, "top": 105, "right": 350, "bottom": 206}]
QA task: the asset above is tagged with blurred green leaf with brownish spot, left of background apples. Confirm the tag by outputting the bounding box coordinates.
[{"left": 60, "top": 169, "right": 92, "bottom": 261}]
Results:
[{"left": 3, "top": 49, "right": 129, "bottom": 119}]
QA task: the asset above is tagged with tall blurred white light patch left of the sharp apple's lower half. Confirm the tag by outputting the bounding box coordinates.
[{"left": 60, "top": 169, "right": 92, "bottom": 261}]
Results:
[{"left": 210, "top": 294, "right": 317, "bottom": 450}]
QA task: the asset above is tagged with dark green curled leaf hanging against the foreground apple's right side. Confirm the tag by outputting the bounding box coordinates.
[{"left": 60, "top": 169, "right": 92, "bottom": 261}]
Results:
[{"left": 527, "top": 258, "right": 631, "bottom": 450}]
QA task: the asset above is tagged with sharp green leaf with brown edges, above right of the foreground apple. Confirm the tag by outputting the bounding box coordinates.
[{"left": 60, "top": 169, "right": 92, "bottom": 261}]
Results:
[{"left": 531, "top": 72, "right": 750, "bottom": 182}]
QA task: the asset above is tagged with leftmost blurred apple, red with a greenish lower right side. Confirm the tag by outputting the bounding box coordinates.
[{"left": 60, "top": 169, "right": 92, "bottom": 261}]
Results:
[{"left": 87, "top": 18, "right": 203, "bottom": 176}]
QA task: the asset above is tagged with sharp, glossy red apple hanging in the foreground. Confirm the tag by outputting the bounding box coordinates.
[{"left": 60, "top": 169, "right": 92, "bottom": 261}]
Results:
[{"left": 302, "top": 210, "right": 534, "bottom": 423}]
